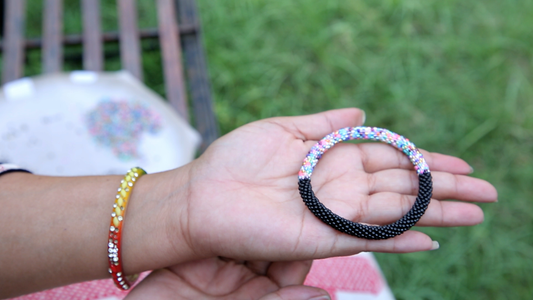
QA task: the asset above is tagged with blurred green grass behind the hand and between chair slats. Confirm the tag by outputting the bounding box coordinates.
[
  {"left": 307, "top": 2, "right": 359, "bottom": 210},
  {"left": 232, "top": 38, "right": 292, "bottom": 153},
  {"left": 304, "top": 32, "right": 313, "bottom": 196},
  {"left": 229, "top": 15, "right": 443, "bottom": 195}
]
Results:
[{"left": 16, "top": 0, "right": 533, "bottom": 299}]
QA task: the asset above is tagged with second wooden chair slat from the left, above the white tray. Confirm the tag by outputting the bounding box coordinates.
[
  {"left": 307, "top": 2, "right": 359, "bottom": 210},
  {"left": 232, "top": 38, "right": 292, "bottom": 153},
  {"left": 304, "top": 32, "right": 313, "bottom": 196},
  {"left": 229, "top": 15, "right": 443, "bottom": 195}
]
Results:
[{"left": 42, "top": 0, "right": 63, "bottom": 73}]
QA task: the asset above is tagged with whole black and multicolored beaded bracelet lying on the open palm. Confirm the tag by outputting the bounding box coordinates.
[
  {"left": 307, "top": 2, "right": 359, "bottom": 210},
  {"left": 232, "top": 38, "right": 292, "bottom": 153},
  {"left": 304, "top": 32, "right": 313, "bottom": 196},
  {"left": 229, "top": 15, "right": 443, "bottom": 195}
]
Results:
[{"left": 298, "top": 127, "right": 433, "bottom": 240}]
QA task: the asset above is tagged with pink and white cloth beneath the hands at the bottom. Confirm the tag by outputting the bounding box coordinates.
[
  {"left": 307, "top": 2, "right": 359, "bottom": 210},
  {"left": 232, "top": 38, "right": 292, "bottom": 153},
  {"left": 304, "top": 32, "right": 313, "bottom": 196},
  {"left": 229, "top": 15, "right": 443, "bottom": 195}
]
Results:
[{"left": 10, "top": 253, "right": 394, "bottom": 300}]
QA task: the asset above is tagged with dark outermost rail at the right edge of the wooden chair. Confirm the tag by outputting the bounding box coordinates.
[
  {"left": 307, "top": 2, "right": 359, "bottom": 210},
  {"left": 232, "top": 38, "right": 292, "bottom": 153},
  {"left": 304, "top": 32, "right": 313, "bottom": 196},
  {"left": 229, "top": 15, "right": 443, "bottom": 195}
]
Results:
[{"left": 176, "top": 0, "right": 219, "bottom": 152}]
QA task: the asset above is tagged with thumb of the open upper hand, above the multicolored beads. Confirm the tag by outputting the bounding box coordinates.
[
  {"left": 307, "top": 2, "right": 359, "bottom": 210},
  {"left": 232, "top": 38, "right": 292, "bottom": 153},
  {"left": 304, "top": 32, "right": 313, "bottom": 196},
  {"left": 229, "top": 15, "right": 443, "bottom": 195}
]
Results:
[{"left": 270, "top": 108, "right": 365, "bottom": 141}]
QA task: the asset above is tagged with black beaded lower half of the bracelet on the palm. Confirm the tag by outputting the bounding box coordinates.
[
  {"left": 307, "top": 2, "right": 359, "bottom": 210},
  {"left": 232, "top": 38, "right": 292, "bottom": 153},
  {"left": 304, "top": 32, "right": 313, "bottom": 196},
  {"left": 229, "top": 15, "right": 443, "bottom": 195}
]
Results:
[{"left": 298, "top": 172, "right": 433, "bottom": 240}]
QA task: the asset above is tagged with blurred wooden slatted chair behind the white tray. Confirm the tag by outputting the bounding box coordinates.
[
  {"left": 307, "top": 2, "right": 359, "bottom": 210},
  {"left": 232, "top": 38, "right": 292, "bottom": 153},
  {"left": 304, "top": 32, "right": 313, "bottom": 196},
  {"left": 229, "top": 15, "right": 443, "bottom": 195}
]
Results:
[{"left": 0, "top": 0, "right": 218, "bottom": 151}]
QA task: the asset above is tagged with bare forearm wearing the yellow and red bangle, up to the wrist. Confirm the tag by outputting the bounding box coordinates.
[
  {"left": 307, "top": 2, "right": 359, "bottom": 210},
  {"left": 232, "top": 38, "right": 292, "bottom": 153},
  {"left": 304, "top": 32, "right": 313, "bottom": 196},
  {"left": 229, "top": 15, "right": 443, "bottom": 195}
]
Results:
[{"left": 0, "top": 165, "right": 194, "bottom": 298}]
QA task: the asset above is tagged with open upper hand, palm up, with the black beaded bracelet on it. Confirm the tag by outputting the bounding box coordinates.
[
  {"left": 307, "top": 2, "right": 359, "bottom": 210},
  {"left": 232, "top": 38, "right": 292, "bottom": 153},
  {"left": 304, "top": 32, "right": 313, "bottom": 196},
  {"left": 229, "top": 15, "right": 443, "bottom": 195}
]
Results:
[{"left": 171, "top": 109, "right": 497, "bottom": 261}]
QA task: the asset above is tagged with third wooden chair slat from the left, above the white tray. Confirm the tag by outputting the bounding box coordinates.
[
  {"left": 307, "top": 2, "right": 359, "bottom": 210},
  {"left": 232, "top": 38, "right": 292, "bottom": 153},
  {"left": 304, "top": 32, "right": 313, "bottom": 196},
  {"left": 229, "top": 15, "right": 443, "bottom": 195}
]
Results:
[{"left": 81, "top": 0, "right": 103, "bottom": 71}]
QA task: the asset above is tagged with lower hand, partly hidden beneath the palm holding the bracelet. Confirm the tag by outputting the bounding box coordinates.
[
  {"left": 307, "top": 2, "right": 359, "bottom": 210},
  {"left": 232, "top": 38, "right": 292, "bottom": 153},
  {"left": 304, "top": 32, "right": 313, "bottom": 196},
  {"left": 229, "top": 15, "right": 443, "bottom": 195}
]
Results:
[{"left": 126, "top": 258, "right": 330, "bottom": 300}]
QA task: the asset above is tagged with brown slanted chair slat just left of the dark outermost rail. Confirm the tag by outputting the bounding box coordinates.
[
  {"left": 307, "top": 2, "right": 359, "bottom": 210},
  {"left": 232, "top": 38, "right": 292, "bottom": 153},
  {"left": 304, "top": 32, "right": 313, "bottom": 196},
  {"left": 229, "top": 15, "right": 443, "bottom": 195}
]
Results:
[{"left": 157, "top": 0, "right": 189, "bottom": 121}]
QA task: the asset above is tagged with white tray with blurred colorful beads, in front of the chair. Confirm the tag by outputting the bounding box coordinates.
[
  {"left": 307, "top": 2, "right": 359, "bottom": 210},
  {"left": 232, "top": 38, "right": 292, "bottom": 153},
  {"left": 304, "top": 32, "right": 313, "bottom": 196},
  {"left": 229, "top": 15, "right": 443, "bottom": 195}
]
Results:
[{"left": 0, "top": 71, "right": 200, "bottom": 176}]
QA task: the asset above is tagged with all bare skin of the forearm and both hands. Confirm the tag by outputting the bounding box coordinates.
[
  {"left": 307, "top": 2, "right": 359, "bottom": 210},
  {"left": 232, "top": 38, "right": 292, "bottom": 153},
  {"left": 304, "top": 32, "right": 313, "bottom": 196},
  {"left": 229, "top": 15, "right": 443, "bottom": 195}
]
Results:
[{"left": 0, "top": 109, "right": 497, "bottom": 299}]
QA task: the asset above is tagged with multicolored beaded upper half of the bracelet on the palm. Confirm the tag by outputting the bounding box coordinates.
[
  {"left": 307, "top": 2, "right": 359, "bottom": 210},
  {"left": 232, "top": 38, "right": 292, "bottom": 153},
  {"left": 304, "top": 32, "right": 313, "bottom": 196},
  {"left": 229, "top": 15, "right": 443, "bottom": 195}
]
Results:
[{"left": 298, "top": 126, "right": 429, "bottom": 179}]
